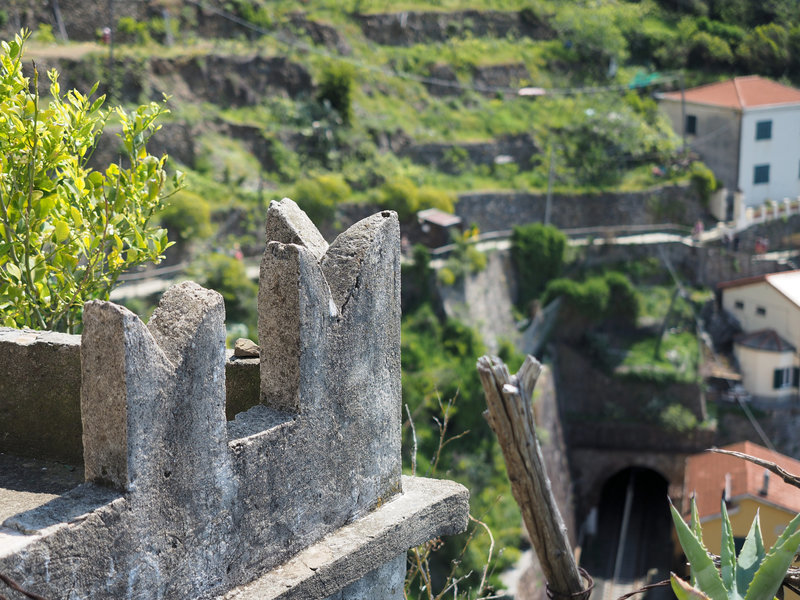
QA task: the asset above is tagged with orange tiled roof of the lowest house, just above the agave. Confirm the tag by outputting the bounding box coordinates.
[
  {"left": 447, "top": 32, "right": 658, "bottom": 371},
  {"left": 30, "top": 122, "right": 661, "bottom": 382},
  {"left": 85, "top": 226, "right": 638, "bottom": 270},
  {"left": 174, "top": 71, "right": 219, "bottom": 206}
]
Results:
[{"left": 684, "top": 442, "right": 800, "bottom": 520}]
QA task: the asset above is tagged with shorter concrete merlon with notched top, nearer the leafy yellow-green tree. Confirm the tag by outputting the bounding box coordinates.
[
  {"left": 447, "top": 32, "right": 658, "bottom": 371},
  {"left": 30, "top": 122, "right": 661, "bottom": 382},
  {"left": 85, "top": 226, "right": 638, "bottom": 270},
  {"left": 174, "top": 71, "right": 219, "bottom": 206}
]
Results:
[{"left": 81, "top": 282, "right": 227, "bottom": 491}]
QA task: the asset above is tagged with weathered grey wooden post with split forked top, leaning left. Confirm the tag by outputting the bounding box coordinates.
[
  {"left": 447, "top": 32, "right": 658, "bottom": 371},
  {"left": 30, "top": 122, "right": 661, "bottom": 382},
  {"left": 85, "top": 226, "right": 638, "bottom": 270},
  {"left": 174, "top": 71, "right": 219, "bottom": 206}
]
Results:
[{"left": 478, "top": 355, "right": 591, "bottom": 600}]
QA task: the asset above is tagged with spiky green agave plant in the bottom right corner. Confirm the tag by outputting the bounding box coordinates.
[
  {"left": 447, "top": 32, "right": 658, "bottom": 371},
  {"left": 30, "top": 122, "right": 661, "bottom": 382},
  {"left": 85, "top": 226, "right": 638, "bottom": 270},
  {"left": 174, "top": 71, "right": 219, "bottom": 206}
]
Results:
[{"left": 670, "top": 500, "right": 800, "bottom": 600}]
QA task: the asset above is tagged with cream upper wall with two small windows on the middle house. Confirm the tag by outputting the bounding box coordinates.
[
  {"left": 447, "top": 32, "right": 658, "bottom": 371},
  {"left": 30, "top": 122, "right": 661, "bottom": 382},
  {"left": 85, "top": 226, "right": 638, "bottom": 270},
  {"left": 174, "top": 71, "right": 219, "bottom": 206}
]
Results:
[{"left": 722, "top": 281, "right": 800, "bottom": 348}]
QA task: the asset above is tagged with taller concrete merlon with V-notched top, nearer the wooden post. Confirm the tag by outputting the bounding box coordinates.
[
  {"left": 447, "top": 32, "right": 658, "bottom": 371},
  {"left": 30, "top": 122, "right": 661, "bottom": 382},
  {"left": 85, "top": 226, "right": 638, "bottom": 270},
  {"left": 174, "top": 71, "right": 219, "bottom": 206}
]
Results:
[{"left": 258, "top": 198, "right": 400, "bottom": 413}]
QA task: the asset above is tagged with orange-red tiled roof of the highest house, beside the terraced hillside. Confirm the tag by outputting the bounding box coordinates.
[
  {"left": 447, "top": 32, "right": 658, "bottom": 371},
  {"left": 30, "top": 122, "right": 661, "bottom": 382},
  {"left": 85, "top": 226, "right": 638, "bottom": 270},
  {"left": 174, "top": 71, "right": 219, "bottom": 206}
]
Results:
[{"left": 661, "top": 75, "right": 800, "bottom": 109}]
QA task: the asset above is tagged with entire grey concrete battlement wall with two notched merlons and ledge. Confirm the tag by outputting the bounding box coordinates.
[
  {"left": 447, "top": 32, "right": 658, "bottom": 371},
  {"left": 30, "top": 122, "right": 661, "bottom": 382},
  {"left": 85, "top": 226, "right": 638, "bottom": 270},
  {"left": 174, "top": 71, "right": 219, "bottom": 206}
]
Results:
[{"left": 0, "top": 199, "right": 468, "bottom": 600}]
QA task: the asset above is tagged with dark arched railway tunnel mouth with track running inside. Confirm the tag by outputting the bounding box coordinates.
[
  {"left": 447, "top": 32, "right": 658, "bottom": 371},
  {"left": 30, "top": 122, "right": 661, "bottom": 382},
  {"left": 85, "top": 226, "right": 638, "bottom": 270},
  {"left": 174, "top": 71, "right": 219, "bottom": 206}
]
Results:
[{"left": 581, "top": 467, "right": 672, "bottom": 600}]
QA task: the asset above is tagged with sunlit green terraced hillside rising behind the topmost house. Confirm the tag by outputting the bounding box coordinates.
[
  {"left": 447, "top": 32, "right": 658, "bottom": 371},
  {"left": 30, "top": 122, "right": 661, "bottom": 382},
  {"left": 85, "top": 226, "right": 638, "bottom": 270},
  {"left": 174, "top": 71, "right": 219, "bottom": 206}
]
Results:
[{"left": 7, "top": 0, "right": 800, "bottom": 262}]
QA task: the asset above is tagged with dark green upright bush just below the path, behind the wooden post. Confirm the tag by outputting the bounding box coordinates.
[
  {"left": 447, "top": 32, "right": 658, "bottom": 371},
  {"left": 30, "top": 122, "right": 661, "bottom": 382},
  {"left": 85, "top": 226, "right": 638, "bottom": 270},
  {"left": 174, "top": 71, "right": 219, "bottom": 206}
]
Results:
[{"left": 511, "top": 223, "right": 567, "bottom": 306}]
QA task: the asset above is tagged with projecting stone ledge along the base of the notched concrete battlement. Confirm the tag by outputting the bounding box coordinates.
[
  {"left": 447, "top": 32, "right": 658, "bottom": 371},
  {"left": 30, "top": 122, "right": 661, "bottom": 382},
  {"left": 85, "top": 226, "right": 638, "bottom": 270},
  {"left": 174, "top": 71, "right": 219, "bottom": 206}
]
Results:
[{"left": 218, "top": 476, "right": 469, "bottom": 600}]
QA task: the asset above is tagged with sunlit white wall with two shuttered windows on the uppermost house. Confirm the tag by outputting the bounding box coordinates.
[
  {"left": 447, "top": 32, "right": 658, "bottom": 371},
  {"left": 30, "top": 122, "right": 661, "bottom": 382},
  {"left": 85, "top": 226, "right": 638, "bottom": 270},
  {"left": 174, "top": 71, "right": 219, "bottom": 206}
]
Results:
[{"left": 739, "top": 105, "right": 800, "bottom": 206}]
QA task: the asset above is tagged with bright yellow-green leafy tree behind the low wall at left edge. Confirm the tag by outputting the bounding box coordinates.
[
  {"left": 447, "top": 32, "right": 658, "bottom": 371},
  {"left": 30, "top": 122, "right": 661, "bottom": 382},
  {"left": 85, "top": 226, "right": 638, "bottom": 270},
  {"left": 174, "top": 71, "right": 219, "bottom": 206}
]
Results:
[{"left": 0, "top": 32, "right": 180, "bottom": 332}]
